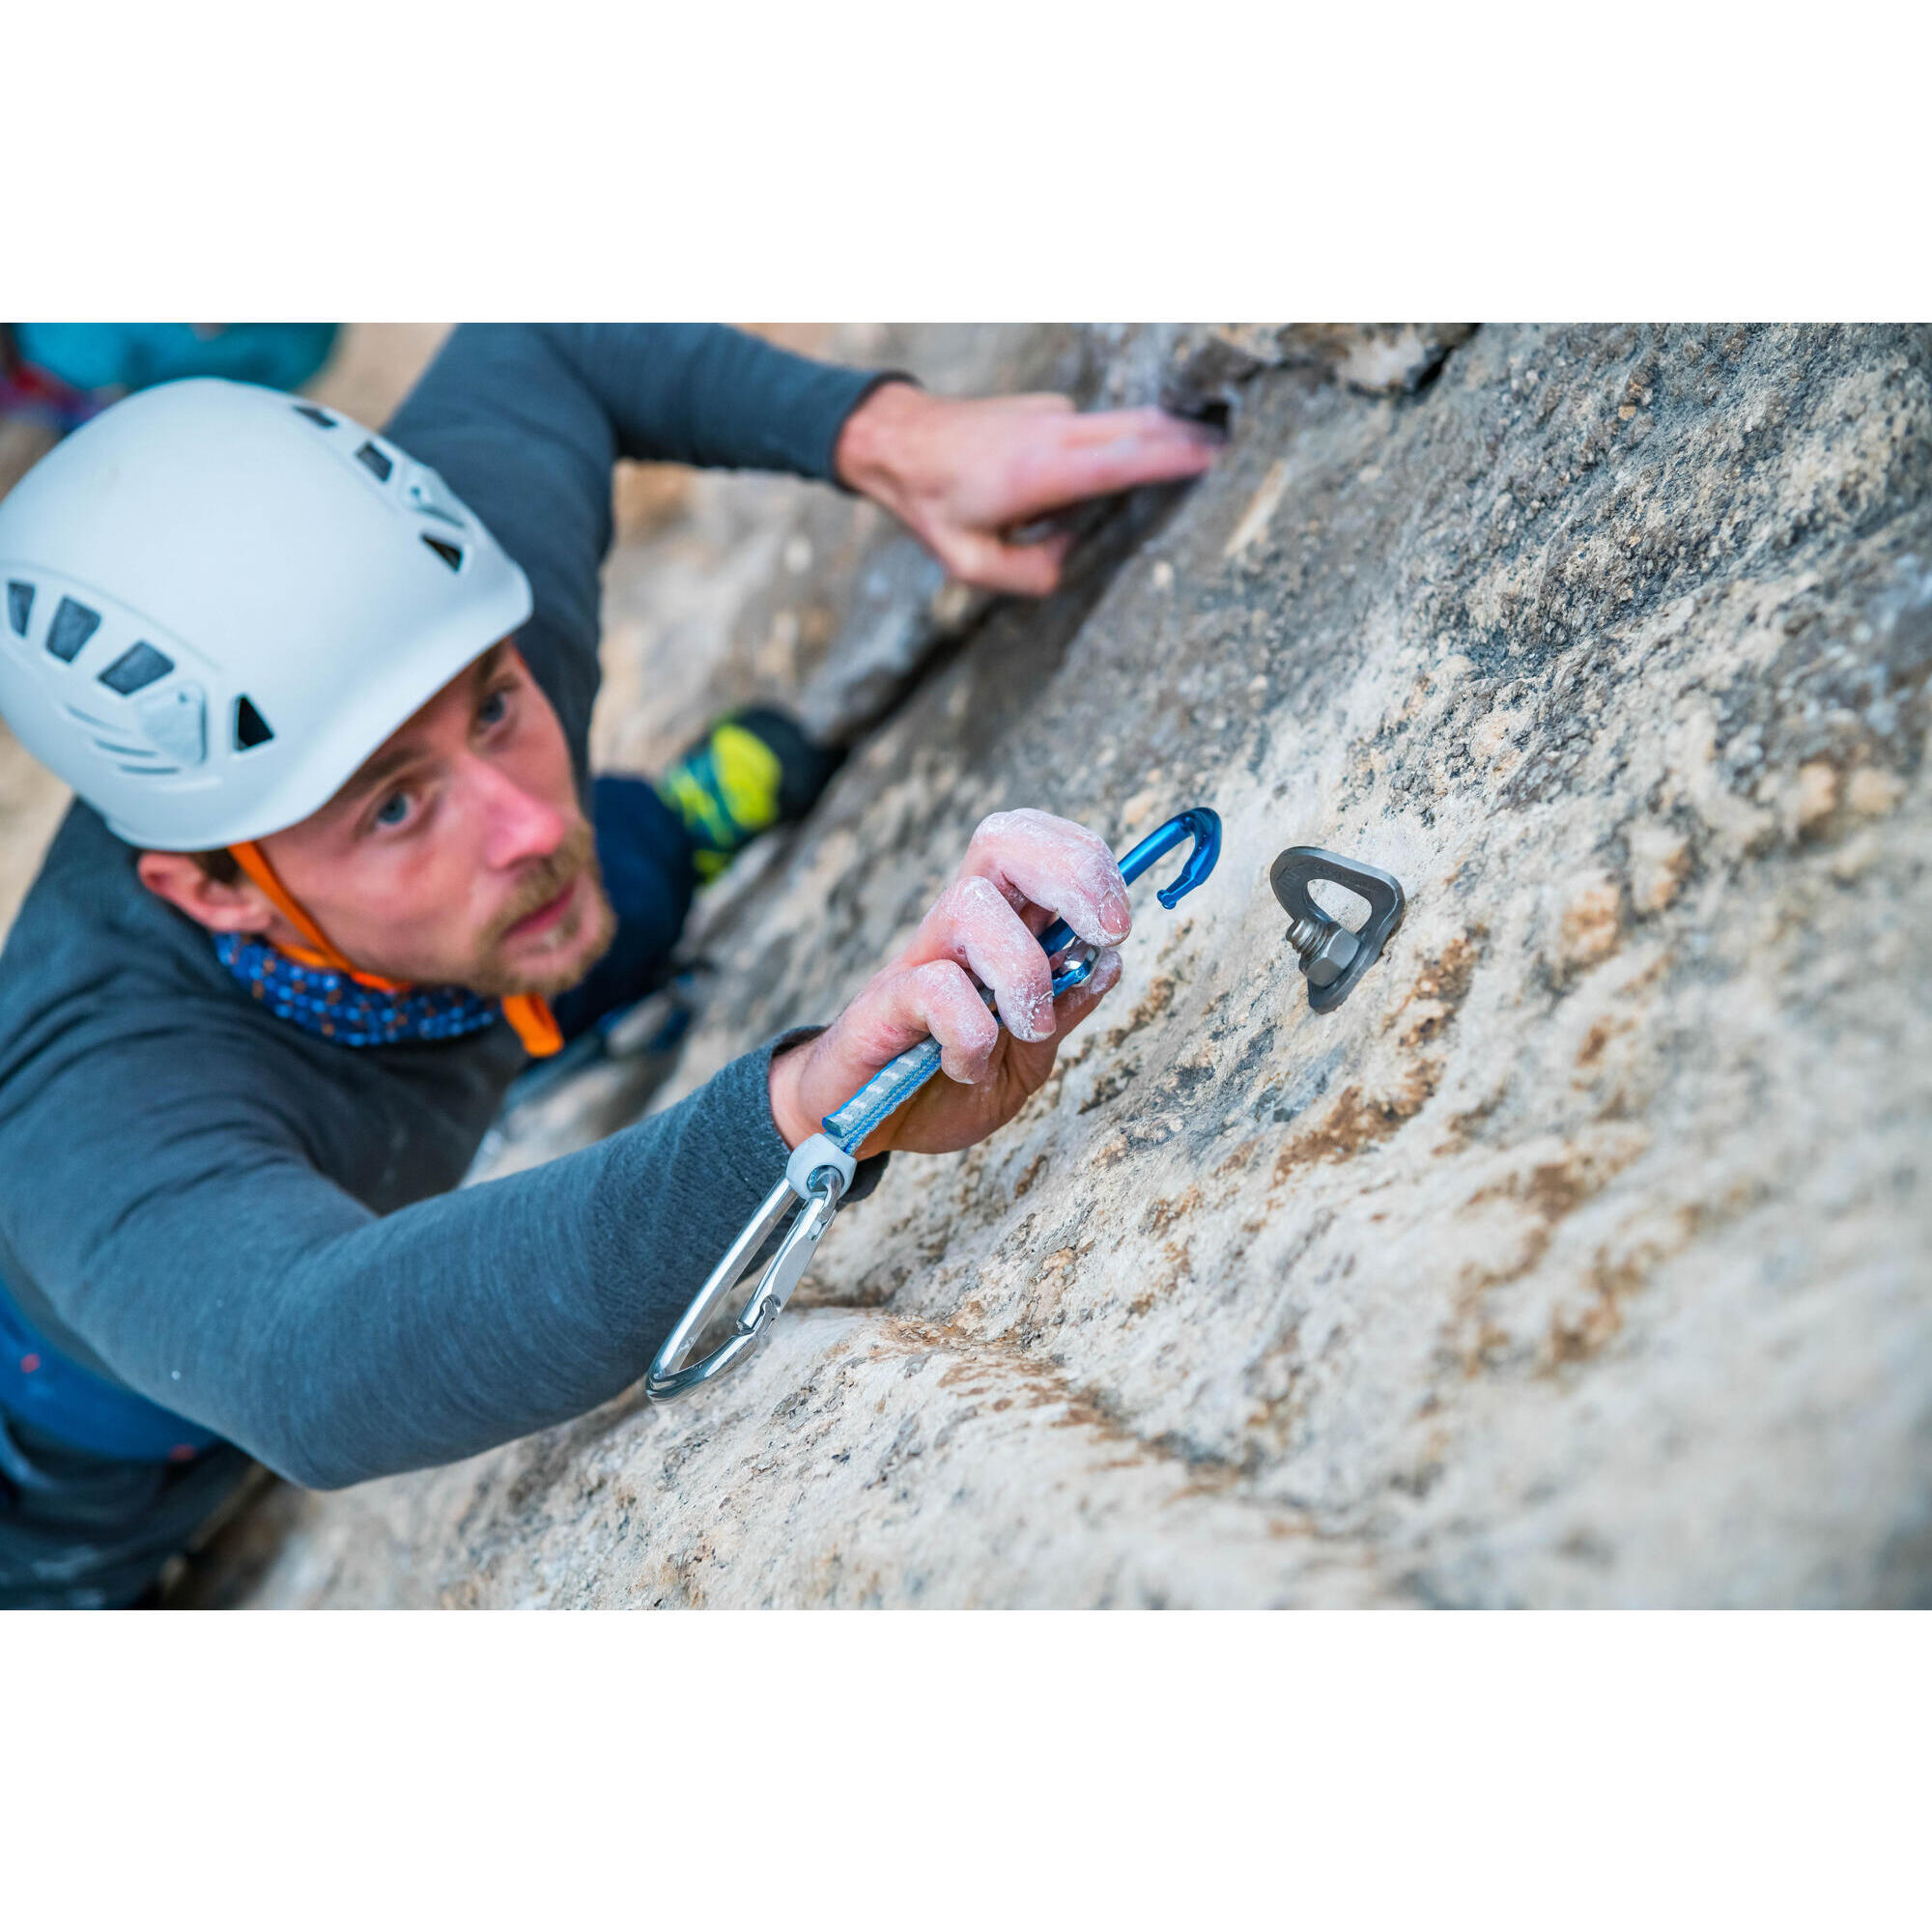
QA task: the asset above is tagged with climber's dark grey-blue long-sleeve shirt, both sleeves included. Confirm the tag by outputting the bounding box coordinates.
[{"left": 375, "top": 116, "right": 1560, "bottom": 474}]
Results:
[{"left": 0, "top": 327, "right": 877, "bottom": 1488}]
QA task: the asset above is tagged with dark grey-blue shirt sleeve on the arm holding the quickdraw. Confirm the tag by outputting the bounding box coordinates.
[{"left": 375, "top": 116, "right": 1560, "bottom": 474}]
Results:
[{"left": 6, "top": 1036, "right": 804, "bottom": 1488}]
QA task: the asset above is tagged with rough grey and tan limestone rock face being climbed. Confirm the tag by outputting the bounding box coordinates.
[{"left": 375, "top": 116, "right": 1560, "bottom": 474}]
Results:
[{"left": 230, "top": 327, "right": 1932, "bottom": 1605}]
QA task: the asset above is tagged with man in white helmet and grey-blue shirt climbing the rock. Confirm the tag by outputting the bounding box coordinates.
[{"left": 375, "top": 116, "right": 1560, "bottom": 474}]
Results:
[{"left": 0, "top": 327, "right": 1213, "bottom": 1605}]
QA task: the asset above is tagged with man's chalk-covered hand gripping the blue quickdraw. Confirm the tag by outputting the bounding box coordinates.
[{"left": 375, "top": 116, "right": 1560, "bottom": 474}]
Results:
[{"left": 771, "top": 810, "right": 1134, "bottom": 1157}]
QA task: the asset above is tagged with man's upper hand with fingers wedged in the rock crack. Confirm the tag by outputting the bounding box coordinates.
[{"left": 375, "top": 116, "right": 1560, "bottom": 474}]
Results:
[{"left": 835, "top": 383, "right": 1221, "bottom": 597}]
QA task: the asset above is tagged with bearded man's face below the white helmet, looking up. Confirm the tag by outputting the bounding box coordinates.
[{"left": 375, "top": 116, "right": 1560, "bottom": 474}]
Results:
[{"left": 261, "top": 641, "right": 616, "bottom": 995}]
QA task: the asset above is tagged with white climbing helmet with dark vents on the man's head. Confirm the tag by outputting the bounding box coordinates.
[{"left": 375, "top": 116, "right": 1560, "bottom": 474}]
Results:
[{"left": 0, "top": 379, "right": 531, "bottom": 852}]
